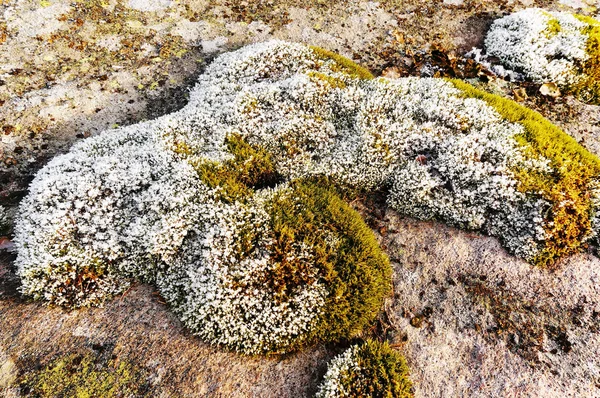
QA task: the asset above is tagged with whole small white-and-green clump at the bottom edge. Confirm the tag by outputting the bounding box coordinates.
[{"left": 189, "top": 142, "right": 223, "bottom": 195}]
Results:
[{"left": 317, "top": 340, "right": 414, "bottom": 398}]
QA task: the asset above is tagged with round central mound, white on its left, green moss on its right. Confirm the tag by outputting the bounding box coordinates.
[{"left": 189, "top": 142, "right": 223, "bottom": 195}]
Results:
[{"left": 158, "top": 171, "right": 391, "bottom": 354}]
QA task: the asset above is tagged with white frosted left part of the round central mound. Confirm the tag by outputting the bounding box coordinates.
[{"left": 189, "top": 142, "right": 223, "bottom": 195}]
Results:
[{"left": 158, "top": 188, "right": 327, "bottom": 354}]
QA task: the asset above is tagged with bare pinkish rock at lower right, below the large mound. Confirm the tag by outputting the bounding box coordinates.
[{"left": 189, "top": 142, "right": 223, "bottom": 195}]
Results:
[{"left": 381, "top": 215, "right": 600, "bottom": 397}]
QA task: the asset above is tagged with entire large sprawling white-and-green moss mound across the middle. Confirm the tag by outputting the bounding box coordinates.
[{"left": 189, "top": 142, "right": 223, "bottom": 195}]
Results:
[{"left": 15, "top": 41, "right": 600, "bottom": 354}]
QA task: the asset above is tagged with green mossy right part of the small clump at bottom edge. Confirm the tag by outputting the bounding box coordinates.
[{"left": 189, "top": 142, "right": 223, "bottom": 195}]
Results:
[{"left": 342, "top": 340, "right": 414, "bottom": 398}]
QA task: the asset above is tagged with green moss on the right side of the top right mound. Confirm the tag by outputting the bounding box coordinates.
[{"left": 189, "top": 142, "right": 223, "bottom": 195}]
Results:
[{"left": 572, "top": 14, "right": 600, "bottom": 104}]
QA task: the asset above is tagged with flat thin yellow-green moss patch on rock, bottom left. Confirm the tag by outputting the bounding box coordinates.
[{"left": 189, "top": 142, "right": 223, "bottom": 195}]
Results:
[{"left": 19, "top": 353, "right": 151, "bottom": 398}]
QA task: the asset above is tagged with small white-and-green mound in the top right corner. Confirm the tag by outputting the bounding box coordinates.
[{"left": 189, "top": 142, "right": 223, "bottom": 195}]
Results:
[{"left": 485, "top": 8, "right": 600, "bottom": 103}]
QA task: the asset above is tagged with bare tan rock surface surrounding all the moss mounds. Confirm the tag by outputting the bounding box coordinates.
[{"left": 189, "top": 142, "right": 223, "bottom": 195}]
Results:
[{"left": 0, "top": 0, "right": 600, "bottom": 397}]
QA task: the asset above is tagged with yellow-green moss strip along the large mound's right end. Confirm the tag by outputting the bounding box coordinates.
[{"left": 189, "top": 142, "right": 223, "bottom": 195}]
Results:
[{"left": 451, "top": 80, "right": 600, "bottom": 265}]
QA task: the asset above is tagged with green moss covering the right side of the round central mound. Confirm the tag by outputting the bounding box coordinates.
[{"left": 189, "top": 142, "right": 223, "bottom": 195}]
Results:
[{"left": 268, "top": 180, "right": 391, "bottom": 350}]
